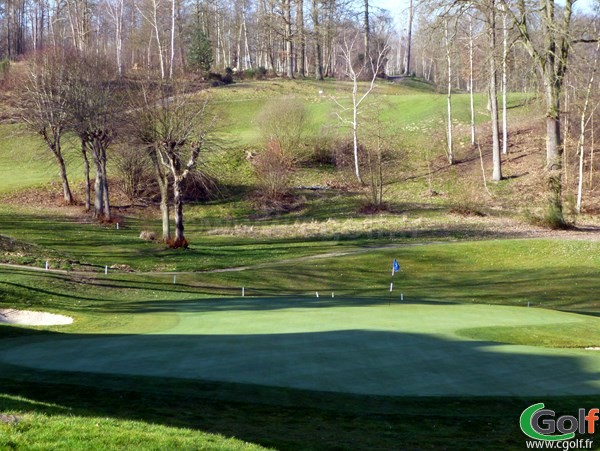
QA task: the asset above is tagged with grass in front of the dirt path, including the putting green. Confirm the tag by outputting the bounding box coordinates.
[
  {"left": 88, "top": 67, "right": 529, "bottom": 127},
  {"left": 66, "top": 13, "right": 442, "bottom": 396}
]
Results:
[{"left": 0, "top": 240, "right": 600, "bottom": 449}]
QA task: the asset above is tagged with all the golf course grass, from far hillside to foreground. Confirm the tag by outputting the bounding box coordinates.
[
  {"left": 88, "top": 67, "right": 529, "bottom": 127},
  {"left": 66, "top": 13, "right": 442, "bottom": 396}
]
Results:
[{"left": 0, "top": 80, "right": 600, "bottom": 450}]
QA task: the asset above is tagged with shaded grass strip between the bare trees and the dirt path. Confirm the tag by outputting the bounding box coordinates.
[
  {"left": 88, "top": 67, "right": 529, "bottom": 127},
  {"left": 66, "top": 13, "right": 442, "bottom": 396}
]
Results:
[{"left": 0, "top": 210, "right": 540, "bottom": 271}]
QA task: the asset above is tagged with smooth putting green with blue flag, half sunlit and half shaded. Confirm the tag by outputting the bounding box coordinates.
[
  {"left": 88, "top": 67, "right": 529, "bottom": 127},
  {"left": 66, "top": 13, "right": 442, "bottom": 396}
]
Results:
[{"left": 0, "top": 298, "right": 600, "bottom": 396}]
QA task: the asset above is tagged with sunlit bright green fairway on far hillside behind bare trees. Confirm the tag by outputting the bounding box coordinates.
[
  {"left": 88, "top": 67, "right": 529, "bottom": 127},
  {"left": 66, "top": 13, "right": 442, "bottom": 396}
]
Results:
[{"left": 0, "top": 81, "right": 536, "bottom": 192}]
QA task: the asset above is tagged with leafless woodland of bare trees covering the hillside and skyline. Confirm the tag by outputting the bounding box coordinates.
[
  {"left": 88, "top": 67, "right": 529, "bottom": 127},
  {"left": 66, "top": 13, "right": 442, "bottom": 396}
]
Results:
[{"left": 0, "top": 0, "right": 600, "bottom": 240}]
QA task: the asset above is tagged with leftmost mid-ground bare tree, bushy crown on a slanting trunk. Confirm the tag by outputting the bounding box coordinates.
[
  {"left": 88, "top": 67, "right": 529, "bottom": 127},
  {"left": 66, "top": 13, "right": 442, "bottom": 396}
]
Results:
[{"left": 22, "top": 49, "right": 73, "bottom": 204}]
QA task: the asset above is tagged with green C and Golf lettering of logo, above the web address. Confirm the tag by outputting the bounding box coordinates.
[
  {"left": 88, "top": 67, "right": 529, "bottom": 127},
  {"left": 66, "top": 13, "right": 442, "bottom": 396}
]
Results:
[{"left": 520, "top": 402, "right": 600, "bottom": 441}]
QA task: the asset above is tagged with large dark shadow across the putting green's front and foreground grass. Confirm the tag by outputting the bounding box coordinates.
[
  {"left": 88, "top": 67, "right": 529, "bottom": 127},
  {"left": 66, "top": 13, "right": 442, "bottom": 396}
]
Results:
[{"left": 0, "top": 330, "right": 598, "bottom": 449}]
